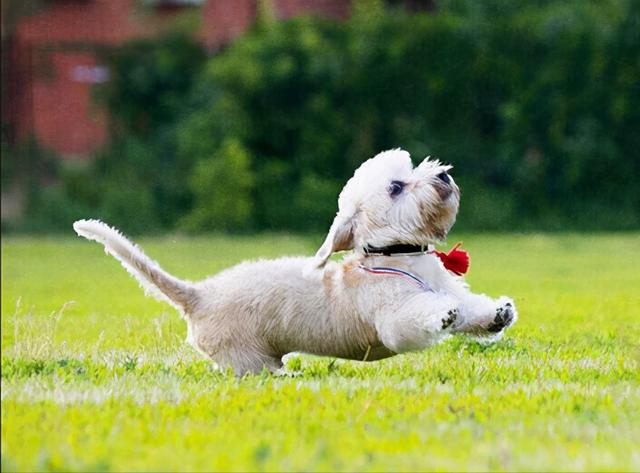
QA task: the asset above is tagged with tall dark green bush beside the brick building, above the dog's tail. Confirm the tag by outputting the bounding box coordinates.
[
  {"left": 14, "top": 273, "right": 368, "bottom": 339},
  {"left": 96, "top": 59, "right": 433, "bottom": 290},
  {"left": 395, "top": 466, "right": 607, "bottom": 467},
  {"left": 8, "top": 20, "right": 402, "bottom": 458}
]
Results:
[{"left": 94, "top": 32, "right": 206, "bottom": 232}]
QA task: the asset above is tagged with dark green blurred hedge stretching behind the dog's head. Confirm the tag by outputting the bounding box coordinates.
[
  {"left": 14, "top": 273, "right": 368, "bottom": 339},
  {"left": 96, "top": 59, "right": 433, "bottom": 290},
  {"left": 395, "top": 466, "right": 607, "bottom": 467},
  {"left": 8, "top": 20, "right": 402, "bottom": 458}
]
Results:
[{"left": 6, "top": 0, "right": 640, "bottom": 231}]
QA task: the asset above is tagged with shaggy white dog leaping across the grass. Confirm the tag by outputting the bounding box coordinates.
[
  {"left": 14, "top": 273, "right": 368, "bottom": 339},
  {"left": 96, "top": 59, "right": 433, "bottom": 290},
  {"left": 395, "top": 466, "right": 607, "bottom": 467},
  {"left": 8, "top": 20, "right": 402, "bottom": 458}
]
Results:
[{"left": 73, "top": 150, "right": 517, "bottom": 375}]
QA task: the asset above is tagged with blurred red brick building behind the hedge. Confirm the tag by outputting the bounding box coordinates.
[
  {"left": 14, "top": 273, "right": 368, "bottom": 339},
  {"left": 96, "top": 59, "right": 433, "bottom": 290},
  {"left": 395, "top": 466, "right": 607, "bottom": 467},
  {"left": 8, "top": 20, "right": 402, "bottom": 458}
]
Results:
[{"left": 2, "top": 0, "right": 351, "bottom": 158}]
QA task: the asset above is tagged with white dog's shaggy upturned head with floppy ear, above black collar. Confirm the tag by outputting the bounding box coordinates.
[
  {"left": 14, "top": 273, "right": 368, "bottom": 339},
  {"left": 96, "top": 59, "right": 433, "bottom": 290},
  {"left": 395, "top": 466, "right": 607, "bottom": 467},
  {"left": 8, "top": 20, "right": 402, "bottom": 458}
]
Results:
[{"left": 316, "top": 149, "right": 460, "bottom": 267}]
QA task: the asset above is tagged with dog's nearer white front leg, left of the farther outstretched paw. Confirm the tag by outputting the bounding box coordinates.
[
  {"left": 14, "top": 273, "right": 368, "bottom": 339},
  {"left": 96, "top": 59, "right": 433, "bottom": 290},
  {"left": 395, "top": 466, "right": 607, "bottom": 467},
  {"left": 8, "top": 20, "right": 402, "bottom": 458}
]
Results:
[{"left": 376, "top": 292, "right": 459, "bottom": 353}]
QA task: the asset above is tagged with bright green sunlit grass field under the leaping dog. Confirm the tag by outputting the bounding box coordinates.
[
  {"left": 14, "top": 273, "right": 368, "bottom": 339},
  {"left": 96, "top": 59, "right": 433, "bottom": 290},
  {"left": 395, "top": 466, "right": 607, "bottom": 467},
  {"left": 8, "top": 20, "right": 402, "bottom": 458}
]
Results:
[{"left": 2, "top": 234, "right": 640, "bottom": 471}]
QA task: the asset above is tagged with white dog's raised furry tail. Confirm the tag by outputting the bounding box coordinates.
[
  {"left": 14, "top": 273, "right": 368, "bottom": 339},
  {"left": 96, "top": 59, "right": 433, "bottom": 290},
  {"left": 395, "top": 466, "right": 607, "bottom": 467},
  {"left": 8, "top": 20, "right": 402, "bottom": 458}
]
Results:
[{"left": 73, "top": 220, "right": 196, "bottom": 312}]
